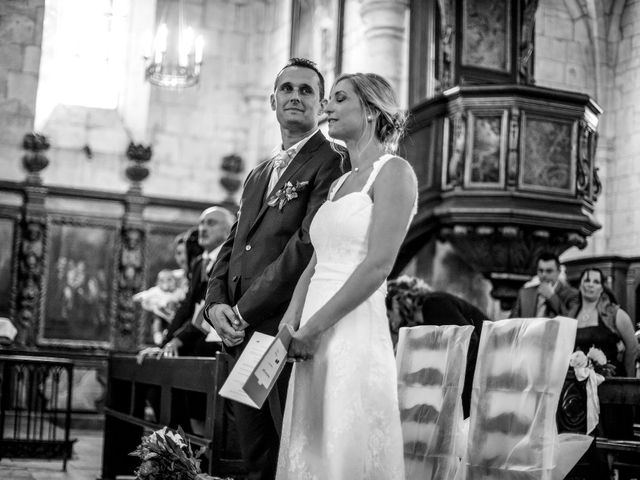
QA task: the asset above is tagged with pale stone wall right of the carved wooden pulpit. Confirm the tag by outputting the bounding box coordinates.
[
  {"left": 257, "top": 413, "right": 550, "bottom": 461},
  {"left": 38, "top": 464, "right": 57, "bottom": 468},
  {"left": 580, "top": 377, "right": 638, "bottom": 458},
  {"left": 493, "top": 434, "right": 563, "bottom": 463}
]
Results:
[{"left": 535, "top": 0, "right": 640, "bottom": 260}]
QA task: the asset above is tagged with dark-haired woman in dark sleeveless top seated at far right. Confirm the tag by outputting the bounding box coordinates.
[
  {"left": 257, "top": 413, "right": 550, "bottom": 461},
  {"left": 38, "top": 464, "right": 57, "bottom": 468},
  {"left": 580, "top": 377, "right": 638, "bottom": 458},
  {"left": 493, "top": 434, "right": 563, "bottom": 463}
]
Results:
[{"left": 564, "top": 268, "right": 638, "bottom": 377}]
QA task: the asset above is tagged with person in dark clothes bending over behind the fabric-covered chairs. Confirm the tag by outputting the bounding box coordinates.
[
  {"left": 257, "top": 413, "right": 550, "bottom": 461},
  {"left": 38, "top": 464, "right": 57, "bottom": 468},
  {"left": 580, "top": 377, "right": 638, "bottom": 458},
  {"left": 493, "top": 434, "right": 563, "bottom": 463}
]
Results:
[{"left": 387, "top": 275, "right": 487, "bottom": 418}]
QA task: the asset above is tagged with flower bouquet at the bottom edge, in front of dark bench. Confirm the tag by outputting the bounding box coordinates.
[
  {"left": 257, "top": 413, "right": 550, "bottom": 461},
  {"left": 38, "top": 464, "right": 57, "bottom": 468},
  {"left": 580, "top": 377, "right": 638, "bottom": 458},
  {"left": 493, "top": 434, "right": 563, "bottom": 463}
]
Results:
[{"left": 129, "top": 427, "right": 231, "bottom": 480}]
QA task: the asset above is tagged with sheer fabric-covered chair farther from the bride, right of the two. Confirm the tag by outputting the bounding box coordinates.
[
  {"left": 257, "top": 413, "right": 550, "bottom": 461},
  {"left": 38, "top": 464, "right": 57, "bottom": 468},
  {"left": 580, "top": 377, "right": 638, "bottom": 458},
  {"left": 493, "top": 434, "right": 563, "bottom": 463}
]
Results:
[{"left": 462, "top": 317, "right": 577, "bottom": 480}]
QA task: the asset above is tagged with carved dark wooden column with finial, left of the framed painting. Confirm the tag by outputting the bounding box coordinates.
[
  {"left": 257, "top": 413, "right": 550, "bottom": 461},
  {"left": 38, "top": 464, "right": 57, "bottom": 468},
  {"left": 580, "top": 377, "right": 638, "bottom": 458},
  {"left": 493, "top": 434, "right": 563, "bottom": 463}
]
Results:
[{"left": 15, "top": 133, "right": 49, "bottom": 347}]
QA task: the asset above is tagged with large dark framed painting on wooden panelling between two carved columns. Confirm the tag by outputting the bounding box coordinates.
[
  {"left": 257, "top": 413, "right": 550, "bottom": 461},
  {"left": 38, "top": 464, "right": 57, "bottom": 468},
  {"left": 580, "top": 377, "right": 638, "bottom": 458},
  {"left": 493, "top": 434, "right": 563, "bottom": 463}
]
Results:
[{"left": 38, "top": 218, "right": 118, "bottom": 347}]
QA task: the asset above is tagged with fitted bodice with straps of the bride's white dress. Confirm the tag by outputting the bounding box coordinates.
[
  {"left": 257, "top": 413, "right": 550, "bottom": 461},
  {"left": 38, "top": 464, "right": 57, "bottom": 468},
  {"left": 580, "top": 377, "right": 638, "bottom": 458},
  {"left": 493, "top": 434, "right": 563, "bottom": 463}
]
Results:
[{"left": 310, "top": 155, "right": 415, "bottom": 280}]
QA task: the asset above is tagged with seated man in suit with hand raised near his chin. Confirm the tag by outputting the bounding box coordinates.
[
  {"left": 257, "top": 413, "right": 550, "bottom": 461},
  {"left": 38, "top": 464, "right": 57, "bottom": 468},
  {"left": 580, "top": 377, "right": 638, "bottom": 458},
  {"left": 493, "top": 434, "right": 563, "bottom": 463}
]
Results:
[{"left": 510, "top": 252, "right": 578, "bottom": 318}]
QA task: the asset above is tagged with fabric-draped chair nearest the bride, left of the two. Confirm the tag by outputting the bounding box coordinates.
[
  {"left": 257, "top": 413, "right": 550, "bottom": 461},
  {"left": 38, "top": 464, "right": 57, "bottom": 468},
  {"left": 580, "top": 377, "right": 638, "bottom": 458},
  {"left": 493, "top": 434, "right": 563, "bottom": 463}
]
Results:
[{"left": 396, "top": 325, "right": 473, "bottom": 480}]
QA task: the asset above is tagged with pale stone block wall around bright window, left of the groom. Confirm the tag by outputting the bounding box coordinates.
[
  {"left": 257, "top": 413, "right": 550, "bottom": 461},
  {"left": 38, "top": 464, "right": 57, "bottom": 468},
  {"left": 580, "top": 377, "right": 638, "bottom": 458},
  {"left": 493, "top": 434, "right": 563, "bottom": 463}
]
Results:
[{"left": 0, "top": 0, "right": 291, "bottom": 203}]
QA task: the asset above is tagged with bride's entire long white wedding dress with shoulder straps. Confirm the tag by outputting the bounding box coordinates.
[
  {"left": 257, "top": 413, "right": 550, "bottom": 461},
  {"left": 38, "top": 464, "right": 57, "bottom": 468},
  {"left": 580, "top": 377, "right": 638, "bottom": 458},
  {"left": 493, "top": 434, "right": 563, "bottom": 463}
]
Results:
[{"left": 276, "top": 155, "right": 415, "bottom": 480}]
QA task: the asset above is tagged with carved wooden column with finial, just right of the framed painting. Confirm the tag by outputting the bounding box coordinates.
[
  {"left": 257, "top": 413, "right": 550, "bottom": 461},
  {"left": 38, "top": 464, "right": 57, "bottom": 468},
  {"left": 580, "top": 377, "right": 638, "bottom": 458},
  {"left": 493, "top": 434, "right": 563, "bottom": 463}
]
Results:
[{"left": 113, "top": 143, "right": 151, "bottom": 351}]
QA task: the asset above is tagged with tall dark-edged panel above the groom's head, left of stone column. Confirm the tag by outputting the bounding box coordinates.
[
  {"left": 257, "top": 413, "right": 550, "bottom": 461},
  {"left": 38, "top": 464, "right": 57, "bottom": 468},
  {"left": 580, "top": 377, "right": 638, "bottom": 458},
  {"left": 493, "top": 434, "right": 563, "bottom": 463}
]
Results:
[{"left": 291, "top": 0, "right": 344, "bottom": 94}]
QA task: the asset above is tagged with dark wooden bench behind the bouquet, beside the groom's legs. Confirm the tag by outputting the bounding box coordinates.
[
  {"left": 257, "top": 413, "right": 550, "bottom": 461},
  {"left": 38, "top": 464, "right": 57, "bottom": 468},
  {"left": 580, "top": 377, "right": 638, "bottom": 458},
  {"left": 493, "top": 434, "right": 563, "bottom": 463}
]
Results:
[{"left": 102, "top": 353, "right": 243, "bottom": 480}]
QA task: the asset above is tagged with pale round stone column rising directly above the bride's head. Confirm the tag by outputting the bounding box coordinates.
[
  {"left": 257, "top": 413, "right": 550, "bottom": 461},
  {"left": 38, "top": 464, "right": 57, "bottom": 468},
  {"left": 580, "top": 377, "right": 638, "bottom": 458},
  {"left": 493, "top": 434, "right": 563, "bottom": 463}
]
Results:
[{"left": 360, "top": 0, "right": 409, "bottom": 94}]
